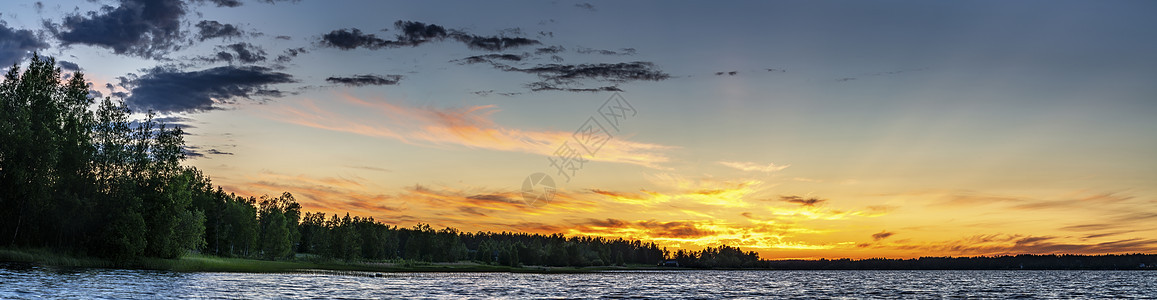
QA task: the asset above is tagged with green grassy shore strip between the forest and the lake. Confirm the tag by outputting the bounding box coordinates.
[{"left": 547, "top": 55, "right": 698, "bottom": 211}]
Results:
[{"left": 0, "top": 248, "right": 615, "bottom": 273}]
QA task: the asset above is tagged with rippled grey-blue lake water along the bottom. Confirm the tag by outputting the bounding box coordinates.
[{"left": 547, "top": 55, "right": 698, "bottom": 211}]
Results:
[{"left": 0, "top": 265, "right": 1157, "bottom": 299}]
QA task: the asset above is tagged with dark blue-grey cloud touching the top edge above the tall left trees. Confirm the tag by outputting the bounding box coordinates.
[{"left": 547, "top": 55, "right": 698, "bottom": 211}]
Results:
[{"left": 47, "top": 0, "right": 185, "bottom": 58}]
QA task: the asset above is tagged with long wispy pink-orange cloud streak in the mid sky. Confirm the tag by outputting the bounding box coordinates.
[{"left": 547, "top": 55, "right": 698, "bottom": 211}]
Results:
[{"left": 272, "top": 95, "right": 672, "bottom": 168}]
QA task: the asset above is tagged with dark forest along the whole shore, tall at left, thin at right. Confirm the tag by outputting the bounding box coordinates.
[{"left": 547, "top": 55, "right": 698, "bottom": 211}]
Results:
[{"left": 0, "top": 54, "right": 1157, "bottom": 269}]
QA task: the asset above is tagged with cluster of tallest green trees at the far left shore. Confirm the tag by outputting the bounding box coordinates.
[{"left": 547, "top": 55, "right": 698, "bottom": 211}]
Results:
[{"left": 0, "top": 54, "right": 197, "bottom": 259}]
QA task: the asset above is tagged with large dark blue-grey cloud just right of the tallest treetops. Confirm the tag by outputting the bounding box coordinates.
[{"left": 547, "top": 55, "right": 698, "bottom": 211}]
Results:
[{"left": 125, "top": 66, "right": 295, "bottom": 112}]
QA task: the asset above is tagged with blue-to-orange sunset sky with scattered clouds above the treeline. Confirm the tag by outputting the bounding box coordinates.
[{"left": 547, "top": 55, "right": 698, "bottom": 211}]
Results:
[{"left": 0, "top": 0, "right": 1157, "bottom": 258}]
